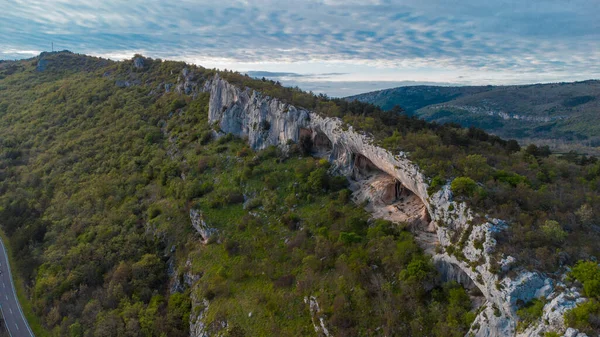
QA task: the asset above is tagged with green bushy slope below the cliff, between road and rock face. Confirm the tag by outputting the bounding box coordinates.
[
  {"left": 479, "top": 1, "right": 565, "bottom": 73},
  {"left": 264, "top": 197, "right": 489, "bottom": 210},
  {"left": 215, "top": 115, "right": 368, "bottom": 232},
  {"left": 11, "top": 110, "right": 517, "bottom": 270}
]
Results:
[{"left": 0, "top": 53, "right": 475, "bottom": 336}]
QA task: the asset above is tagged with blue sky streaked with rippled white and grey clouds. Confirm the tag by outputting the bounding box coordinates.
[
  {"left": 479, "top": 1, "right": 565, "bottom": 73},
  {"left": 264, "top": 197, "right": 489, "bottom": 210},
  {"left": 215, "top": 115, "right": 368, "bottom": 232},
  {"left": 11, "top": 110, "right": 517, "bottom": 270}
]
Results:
[{"left": 0, "top": 0, "right": 600, "bottom": 96}]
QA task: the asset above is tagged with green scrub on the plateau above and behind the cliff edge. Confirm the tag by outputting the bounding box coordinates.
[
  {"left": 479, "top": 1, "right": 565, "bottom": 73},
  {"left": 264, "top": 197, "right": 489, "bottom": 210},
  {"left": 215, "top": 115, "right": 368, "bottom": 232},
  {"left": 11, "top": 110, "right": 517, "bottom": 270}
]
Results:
[{"left": 223, "top": 72, "right": 600, "bottom": 272}]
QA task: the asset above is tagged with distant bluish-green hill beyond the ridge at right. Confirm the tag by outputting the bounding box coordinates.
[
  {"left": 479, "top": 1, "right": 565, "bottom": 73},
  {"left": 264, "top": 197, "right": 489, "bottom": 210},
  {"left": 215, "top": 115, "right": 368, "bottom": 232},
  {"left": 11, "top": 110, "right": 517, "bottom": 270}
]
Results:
[{"left": 347, "top": 80, "right": 600, "bottom": 153}]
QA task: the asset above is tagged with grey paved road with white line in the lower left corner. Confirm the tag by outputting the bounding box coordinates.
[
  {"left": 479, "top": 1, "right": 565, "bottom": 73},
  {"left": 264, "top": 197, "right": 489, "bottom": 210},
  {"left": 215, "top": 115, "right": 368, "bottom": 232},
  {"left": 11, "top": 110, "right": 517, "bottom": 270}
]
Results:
[{"left": 0, "top": 238, "right": 34, "bottom": 337}]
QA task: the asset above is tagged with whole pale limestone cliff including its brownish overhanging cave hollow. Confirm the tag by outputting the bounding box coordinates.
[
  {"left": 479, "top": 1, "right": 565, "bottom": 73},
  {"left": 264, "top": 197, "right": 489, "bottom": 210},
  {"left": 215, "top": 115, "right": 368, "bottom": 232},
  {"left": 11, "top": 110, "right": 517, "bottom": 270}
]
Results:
[{"left": 182, "top": 70, "right": 575, "bottom": 336}]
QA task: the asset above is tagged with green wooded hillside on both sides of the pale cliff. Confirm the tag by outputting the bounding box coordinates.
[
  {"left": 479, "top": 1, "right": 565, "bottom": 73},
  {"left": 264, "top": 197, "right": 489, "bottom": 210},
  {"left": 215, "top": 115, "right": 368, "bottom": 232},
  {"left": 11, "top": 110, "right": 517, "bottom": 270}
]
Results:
[{"left": 0, "top": 52, "right": 600, "bottom": 336}]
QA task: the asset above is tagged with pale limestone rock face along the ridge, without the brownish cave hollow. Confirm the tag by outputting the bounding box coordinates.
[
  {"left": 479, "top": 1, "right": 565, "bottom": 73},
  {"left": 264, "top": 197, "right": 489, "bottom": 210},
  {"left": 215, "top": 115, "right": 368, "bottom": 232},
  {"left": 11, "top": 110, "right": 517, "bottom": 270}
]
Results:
[{"left": 184, "top": 74, "right": 570, "bottom": 337}]
